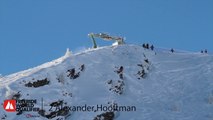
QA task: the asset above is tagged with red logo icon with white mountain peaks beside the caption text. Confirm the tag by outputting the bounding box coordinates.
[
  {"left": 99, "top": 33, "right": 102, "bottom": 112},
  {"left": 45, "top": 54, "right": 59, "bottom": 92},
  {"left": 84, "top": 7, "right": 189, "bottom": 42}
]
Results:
[{"left": 3, "top": 100, "right": 16, "bottom": 112}]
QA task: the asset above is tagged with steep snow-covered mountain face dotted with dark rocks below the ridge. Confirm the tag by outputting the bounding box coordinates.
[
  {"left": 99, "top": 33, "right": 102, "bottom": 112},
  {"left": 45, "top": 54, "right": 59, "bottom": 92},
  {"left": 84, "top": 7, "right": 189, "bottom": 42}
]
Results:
[{"left": 0, "top": 45, "right": 213, "bottom": 120}]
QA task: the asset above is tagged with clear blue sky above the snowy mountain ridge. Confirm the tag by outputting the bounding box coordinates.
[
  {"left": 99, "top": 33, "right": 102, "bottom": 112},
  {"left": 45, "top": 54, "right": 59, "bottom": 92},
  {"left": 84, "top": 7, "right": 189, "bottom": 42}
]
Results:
[{"left": 0, "top": 0, "right": 213, "bottom": 75}]
